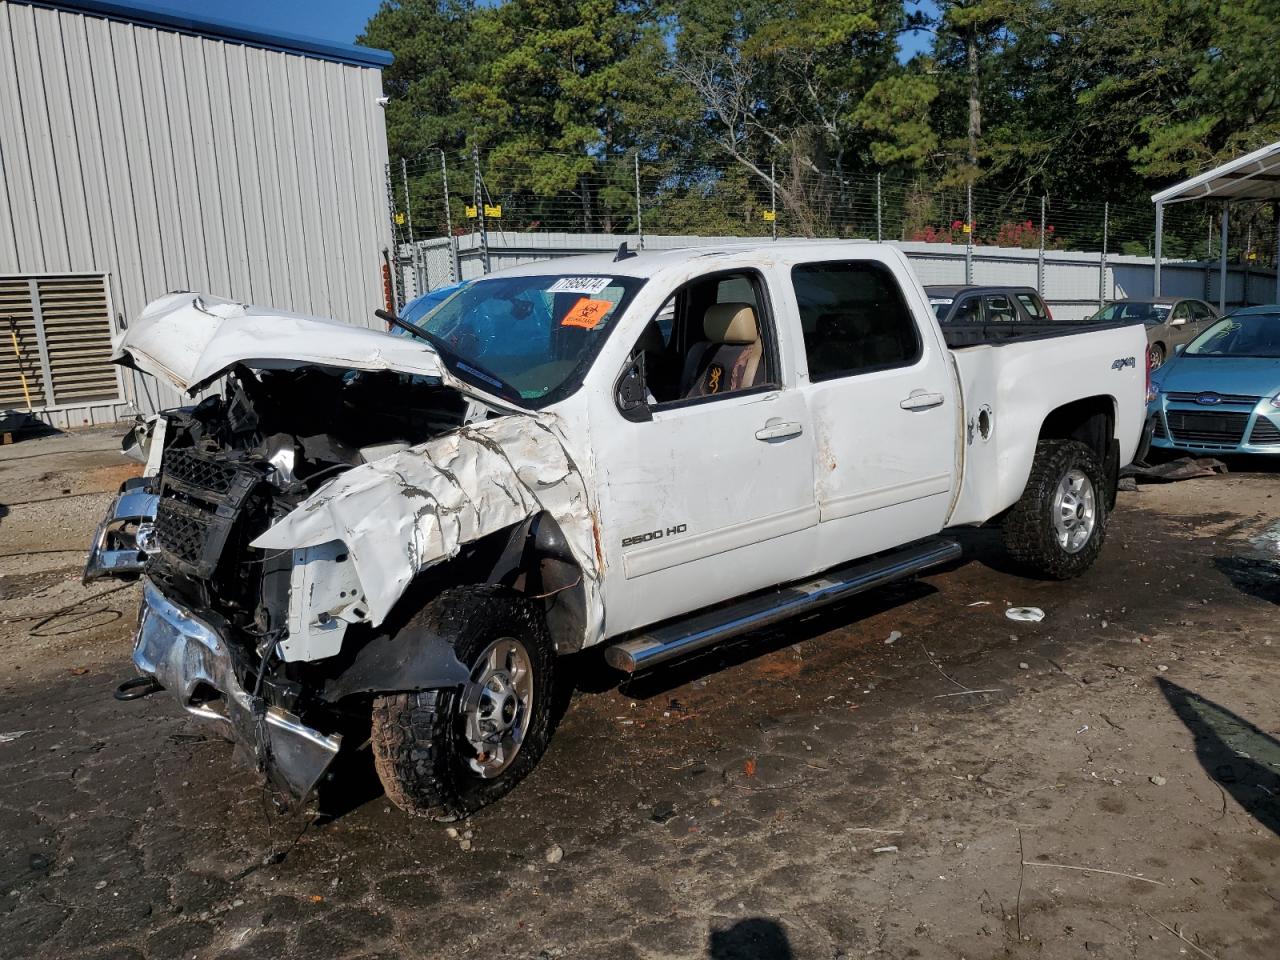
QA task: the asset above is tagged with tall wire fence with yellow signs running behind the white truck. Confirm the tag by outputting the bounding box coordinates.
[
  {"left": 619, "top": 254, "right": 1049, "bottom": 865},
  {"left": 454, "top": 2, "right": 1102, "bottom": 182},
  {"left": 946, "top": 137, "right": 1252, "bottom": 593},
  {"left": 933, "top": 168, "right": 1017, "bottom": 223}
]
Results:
[{"left": 388, "top": 151, "right": 1276, "bottom": 305}]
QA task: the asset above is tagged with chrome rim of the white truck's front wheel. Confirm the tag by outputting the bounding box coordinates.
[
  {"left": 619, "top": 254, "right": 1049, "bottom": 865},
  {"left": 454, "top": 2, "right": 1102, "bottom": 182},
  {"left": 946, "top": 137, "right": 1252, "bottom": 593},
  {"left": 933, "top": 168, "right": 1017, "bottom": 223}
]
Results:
[{"left": 463, "top": 636, "right": 534, "bottom": 780}]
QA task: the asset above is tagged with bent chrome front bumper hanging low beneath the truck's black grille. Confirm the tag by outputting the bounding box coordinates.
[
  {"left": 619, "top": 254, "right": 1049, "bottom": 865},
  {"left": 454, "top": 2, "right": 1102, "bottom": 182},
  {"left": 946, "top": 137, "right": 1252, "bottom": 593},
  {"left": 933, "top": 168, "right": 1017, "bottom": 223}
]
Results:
[{"left": 133, "top": 581, "right": 342, "bottom": 799}]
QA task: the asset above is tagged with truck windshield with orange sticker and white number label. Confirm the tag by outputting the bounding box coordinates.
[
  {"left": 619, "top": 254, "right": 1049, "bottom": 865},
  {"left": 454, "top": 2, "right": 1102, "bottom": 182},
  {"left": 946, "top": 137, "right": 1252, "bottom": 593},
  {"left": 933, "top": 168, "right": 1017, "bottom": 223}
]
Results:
[{"left": 415, "top": 274, "right": 644, "bottom": 406}]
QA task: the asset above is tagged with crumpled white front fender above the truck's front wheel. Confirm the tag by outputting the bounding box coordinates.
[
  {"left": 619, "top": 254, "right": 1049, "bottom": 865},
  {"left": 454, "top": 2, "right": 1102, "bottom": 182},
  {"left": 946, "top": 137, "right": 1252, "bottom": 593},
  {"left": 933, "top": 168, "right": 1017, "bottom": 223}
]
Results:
[{"left": 252, "top": 415, "right": 603, "bottom": 643}]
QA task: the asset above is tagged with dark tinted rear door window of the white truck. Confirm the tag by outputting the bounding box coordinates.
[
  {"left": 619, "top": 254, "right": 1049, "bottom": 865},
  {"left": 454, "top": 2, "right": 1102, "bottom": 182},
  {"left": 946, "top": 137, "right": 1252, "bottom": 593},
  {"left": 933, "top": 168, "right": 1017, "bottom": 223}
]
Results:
[{"left": 791, "top": 261, "right": 922, "bottom": 383}]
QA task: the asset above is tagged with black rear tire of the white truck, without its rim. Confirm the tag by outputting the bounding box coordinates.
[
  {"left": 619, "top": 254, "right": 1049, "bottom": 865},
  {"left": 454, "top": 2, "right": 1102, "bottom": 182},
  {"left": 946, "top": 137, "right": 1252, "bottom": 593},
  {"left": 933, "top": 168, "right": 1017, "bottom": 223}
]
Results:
[{"left": 1004, "top": 440, "right": 1107, "bottom": 580}]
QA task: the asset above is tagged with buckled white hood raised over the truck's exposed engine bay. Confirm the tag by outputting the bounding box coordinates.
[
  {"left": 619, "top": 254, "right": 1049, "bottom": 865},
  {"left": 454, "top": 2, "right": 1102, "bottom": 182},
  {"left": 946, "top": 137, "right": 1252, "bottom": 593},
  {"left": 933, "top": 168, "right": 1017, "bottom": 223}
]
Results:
[{"left": 111, "top": 293, "right": 450, "bottom": 394}]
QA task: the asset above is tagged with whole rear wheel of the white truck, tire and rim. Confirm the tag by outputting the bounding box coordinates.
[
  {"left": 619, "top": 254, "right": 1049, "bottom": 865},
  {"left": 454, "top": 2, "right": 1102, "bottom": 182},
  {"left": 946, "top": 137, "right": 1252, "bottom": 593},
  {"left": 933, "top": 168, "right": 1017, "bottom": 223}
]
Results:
[{"left": 1005, "top": 440, "right": 1107, "bottom": 580}]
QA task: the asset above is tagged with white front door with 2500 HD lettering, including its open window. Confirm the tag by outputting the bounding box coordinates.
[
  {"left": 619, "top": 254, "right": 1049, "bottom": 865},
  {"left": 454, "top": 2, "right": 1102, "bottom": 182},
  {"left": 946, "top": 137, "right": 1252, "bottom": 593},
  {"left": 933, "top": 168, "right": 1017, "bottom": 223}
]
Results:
[{"left": 591, "top": 270, "right": 817, "bottom": 636}]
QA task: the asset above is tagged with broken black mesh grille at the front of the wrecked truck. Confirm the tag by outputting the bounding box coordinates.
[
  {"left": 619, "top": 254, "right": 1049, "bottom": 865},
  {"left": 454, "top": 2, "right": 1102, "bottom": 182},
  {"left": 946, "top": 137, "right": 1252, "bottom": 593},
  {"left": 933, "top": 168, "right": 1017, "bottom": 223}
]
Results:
[{"left": 155, "top": 448, "right": 262, "bottom": 580}]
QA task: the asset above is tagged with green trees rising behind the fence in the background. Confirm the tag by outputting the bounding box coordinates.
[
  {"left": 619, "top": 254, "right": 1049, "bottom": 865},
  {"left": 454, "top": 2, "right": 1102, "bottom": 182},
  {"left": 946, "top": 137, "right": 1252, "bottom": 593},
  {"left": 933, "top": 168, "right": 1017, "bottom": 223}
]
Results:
[{"left": 361, "top": 0, "right": 1280, "bottom": 255}]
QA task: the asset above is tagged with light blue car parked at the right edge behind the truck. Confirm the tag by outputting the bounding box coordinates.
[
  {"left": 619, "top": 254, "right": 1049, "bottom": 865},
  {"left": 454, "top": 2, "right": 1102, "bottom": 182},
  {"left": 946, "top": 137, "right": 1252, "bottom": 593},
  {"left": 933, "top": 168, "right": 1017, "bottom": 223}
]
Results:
[{"left": 1147, "top": 305, "right": 1280, "bottom": 454}]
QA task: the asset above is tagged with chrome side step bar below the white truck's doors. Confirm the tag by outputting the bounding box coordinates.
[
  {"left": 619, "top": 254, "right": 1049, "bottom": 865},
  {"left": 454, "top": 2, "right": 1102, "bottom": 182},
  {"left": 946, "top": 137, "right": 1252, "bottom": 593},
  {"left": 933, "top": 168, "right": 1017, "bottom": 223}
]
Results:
[{"left": 604, "top": 538, "right": 961, "bottom": 673}]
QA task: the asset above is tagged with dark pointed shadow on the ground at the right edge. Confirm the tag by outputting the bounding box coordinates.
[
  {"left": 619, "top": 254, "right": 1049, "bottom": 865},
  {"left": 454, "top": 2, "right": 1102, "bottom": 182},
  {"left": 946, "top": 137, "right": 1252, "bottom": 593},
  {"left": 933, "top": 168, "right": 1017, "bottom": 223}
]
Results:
[{"left": 1156, "top": 677, "right": 1280, "bottom": 836}]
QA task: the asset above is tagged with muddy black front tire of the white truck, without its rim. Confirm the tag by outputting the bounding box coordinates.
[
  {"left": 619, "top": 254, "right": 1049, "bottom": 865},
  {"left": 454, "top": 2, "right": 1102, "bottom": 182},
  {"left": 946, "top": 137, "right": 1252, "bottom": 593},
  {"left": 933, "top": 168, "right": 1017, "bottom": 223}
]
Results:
[{"left": 371, "top": 585, "right": 557, "bottom": 820}]
